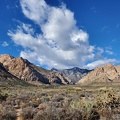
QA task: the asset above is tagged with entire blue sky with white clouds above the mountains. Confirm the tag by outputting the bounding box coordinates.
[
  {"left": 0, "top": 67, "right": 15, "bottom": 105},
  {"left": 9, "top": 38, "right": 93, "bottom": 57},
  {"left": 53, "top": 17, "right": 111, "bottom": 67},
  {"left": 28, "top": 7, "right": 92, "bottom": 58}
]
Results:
[{"left": 0, "top": 0, "right": 120, "bottom": 69}]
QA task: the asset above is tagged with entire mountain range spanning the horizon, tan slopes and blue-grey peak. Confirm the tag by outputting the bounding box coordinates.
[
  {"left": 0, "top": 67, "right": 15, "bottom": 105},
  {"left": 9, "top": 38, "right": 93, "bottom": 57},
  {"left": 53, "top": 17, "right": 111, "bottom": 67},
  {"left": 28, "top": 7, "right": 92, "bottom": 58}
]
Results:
[{"left": 0, "top": 54, "right": 120, "bottom": 85}]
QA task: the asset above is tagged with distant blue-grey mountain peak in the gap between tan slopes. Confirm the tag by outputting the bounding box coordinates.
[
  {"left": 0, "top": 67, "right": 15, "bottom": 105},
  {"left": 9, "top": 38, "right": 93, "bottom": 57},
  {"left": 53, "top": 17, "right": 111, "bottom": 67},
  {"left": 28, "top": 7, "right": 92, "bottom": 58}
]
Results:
[{"left": 51, "top": 67, "right": 91, "bottom": 83}]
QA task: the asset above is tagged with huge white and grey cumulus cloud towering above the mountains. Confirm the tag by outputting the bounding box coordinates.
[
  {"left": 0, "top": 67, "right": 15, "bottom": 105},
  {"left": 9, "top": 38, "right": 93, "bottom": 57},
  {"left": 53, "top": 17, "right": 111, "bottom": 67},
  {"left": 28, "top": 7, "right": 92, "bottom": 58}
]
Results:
[{"left": 8, "top": 0, "right": 116, "bottom": 68}]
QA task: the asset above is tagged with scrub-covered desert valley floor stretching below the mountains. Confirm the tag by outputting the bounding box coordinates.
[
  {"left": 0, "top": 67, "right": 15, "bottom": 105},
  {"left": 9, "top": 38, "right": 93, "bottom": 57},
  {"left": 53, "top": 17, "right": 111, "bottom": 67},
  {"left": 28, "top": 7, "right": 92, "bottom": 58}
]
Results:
[{"left": 0, "top": 83, "right": 120, "bottom": 120}]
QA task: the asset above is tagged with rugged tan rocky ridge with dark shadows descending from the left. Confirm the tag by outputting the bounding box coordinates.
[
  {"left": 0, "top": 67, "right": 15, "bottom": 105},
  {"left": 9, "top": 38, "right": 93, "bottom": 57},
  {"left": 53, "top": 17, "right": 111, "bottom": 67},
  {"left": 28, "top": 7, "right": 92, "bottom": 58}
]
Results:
[{"left": 0, "top": 54, "right": 71, "bottom": 84}]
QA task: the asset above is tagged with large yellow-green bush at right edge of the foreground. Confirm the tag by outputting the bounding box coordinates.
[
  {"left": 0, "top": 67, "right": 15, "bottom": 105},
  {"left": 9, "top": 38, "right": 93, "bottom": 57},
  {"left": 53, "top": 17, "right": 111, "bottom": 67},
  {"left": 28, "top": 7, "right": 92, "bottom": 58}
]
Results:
[{"left": 95, "top": 90, "right": 120, "bottom": 119}]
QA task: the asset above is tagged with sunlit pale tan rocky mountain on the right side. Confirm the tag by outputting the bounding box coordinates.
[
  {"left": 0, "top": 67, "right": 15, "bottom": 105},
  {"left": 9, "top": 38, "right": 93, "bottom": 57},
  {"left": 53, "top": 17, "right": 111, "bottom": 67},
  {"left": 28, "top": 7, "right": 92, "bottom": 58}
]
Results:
[{"left": 78, "top": 64, "right": 120, "bottom": 84}]
